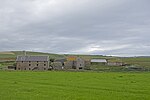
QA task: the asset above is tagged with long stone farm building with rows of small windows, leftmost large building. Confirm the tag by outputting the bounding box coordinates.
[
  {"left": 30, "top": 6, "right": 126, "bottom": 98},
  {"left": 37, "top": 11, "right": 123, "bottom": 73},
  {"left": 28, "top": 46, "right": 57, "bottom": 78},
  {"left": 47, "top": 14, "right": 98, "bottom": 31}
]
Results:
[{"left": 16, "top": 56, "right": 49, "bottom": 70}]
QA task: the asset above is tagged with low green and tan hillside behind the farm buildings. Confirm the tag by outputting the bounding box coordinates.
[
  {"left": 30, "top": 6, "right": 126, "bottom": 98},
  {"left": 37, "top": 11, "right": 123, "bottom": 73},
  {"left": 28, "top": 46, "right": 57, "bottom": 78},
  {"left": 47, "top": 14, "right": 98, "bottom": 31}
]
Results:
[{"left": 0, "top": 51, "right": 150, "bottom": 68}]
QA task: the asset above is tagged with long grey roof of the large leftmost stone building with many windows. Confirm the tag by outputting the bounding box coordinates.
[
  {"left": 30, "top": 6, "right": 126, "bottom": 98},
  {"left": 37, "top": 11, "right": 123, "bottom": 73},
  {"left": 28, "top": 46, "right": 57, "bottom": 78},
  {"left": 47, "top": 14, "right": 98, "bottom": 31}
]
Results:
[{"left": 16, "top": 56, "right": 49, "bottom": 61}]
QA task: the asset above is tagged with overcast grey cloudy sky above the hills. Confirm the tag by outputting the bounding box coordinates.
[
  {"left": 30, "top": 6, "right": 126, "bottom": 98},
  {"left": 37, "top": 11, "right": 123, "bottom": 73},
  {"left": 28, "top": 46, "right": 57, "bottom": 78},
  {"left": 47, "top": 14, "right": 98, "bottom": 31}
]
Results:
[{"left": 0, "top": 0, "right": 150, "bottom": 56}]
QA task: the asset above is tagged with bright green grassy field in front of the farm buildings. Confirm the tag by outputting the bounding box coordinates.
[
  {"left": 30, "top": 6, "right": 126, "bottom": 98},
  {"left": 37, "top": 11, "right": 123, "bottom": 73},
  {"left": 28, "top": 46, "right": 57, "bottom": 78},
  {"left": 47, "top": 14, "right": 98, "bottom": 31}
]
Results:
[{"left": 0, "top": 71, "right": 150, "bottom": 100}]
